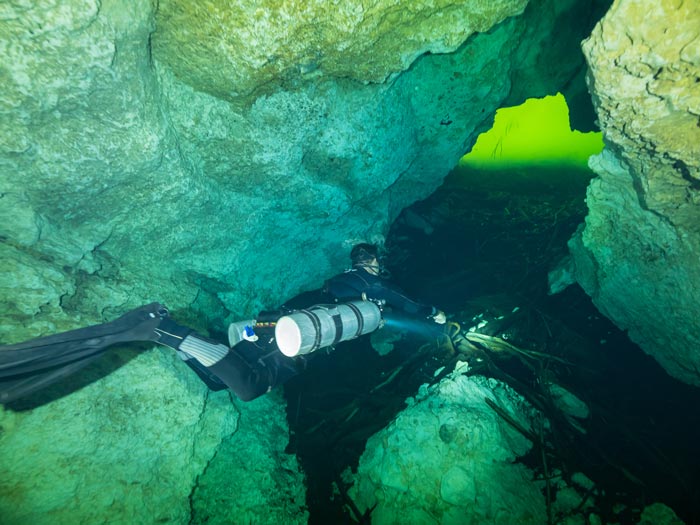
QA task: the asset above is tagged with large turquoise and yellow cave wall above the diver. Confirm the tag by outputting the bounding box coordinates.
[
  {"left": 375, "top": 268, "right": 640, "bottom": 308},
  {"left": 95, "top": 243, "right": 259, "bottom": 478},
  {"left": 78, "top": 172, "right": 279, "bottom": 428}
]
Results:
[{"left": 0, "top": 0, "right": 540, "bottom": 340}]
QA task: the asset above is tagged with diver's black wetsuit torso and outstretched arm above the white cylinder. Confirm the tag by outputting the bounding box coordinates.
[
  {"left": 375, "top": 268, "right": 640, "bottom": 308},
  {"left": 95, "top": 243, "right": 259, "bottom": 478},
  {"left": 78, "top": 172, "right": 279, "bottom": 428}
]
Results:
[{"left": 324, "top": 268, "right": 438, "bottom": 318}]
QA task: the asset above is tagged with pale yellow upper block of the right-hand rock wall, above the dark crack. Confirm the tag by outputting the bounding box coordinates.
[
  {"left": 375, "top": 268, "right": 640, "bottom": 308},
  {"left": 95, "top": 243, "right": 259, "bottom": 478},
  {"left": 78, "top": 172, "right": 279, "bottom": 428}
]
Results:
[{"left": 584, "top": 0, "right": 700, "bottom": 223}]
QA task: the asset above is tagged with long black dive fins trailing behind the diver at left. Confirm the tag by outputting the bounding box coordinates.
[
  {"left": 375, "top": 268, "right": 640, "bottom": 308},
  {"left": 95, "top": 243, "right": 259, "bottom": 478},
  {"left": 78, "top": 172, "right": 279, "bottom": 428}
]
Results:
[{"left": 0, "top": 303, "right": 168, "bottom": 404}]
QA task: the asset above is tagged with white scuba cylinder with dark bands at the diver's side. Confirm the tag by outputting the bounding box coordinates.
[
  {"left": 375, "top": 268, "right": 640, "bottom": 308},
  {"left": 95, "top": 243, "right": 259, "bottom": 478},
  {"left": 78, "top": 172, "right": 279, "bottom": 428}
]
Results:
[{"left": 275, "top": 301, "right": 382, "bottom": 357}]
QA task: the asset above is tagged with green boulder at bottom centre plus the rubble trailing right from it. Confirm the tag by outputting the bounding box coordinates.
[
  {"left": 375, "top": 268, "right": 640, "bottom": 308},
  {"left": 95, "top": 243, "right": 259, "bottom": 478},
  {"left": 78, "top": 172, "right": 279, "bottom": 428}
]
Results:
[{"left": 344, "top": 363, "right": 683, "bottom": 525}]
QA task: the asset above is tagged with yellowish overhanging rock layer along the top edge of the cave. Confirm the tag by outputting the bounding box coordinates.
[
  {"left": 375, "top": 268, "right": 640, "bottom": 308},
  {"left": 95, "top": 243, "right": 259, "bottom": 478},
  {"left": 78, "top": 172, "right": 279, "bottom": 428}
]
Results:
[{"left": 153, "top": 0, "right": 527, "bottom": 102}]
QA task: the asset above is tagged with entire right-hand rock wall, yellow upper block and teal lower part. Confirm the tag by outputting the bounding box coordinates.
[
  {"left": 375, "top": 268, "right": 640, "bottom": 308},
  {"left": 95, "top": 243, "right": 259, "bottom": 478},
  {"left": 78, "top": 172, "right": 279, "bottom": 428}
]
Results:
[{"left": 570, "top": 0, "right": 700, "bottom": 385}]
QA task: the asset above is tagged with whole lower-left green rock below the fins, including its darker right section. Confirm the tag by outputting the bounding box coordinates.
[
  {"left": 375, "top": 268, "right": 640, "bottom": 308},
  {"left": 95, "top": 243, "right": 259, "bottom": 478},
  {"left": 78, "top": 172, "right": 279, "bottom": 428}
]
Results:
[{"left": 0, "top": 350, "right": 307, "bottom": 525}]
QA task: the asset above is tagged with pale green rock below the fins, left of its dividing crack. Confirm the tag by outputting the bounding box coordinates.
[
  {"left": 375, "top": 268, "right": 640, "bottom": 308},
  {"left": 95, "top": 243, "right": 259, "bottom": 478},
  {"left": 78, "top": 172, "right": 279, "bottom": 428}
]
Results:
[{"left": 0, "top": 351, "right": 239, "bottom": 525}]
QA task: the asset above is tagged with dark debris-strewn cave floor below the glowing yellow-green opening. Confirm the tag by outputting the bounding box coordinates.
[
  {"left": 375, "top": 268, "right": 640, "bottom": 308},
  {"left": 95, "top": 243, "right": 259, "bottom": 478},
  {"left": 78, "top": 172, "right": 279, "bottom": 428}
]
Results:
[{"left": 285, "top": 167, "right": 700, "bottom": 524}]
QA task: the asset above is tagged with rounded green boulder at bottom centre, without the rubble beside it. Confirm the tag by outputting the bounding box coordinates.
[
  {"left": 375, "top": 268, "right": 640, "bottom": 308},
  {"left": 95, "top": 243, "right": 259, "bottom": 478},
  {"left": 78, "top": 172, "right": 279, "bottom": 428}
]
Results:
[{"left": 351, "top": 375, "right": 546, "bottom": 525}]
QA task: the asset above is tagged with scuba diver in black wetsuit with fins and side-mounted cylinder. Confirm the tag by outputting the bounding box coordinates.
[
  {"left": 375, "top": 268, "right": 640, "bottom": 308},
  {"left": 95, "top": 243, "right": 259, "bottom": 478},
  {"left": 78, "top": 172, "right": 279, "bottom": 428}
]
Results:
[{"left": 0, "top": 244, "right": 445, "bottom": 404}]
